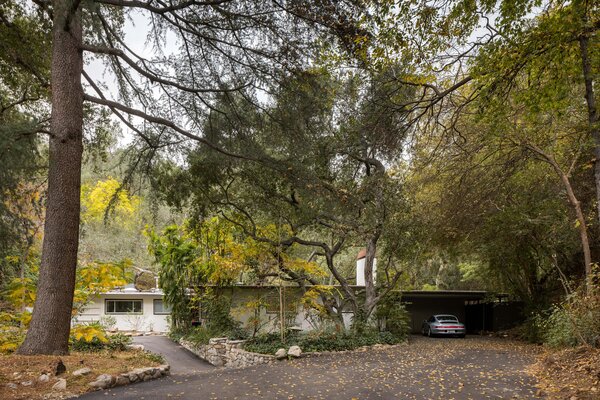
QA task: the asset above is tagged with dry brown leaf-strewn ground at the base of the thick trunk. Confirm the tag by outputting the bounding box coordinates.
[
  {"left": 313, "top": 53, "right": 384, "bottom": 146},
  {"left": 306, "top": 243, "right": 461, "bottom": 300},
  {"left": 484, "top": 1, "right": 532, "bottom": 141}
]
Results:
[{"left": 0, "top": 350, "right": 159, "bottom": 400}]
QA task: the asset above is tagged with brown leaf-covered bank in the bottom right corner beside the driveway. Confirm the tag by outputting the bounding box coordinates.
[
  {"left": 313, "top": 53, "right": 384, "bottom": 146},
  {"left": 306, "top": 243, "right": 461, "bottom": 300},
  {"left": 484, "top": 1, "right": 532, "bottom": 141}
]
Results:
[{"left": 532, "top": 346, "right": 600, "bottom": 400}]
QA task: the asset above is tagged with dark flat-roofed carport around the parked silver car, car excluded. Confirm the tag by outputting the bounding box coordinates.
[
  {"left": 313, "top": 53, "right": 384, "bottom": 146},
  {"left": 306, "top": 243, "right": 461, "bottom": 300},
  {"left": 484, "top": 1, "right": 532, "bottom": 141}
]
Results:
[{"left": 402, "top": 290, "right": 488, "bottom": 333}]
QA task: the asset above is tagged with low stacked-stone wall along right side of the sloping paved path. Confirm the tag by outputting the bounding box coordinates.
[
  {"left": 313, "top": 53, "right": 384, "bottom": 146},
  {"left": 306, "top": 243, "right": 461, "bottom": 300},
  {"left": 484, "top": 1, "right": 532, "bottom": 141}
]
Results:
[{"left": 179, "top": 338, "right": 275, "bottom": 368}]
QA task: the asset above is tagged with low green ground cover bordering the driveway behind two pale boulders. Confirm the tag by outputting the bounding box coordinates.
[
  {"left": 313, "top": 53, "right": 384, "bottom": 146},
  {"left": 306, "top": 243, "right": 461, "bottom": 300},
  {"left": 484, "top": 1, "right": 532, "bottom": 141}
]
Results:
[{"left": 244, "top": 329, "right": 405, "bottom": 354}]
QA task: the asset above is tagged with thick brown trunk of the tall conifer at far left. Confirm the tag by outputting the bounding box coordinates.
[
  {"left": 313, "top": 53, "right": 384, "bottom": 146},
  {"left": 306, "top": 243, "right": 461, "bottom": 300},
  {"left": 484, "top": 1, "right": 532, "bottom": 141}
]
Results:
[{"left": 18, "top": 0, "right": 83, "bottom": 354}]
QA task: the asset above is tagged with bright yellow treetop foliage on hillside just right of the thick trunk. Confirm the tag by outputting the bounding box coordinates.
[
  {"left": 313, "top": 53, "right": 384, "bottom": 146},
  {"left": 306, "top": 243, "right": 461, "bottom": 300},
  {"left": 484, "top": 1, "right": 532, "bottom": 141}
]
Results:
[{"left": 81, "top": 178, "right": 140, "bottom": 226}]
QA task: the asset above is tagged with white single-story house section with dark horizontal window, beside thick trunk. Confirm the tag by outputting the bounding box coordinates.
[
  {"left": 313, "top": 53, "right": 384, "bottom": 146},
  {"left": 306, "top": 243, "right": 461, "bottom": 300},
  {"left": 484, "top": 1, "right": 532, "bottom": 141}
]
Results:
[{"left": 76, "top": 285, "right": 171, "bottom": 333}]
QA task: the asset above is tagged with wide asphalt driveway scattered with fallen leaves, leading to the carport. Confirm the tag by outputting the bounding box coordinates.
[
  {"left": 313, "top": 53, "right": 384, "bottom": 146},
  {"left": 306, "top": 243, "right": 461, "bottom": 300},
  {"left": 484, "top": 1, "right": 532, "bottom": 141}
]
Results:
[{"left": 82, "top": 336, "right": 538, "bottom": 400}]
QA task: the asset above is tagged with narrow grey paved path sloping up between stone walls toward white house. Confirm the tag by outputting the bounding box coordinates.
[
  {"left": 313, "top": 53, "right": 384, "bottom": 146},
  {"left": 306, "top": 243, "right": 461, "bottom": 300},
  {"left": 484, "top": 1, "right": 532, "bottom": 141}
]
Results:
[{"left": 133, "top": 336, "right": 215, "bottom": 375}]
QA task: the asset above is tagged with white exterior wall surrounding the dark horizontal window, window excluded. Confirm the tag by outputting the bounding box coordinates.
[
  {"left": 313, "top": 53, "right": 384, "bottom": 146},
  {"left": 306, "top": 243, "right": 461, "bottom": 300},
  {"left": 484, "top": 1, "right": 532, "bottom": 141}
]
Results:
[{"left": 77, "top": 292, "right": 169, "bottom": 332}]
